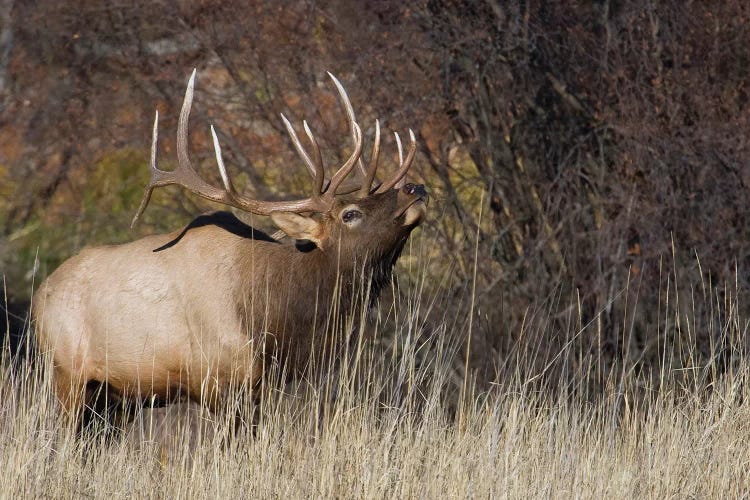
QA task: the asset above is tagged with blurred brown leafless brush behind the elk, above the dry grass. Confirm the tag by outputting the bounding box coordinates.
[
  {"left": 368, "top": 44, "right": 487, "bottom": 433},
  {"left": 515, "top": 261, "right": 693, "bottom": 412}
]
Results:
[{"left": 0, "top": 0, "right": 750, "bottom": 394}]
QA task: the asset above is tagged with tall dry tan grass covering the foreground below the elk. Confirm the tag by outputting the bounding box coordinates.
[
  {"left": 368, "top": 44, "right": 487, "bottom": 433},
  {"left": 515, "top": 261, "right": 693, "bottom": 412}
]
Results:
[{"left": 0, "top": 229, "right": 750, "bottom": 498}]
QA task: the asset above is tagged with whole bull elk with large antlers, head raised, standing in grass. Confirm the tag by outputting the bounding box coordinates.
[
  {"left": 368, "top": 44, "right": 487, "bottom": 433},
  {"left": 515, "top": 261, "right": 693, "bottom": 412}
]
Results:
[{"left": 33, "top": 71, "right": 426, "bottom": 426}]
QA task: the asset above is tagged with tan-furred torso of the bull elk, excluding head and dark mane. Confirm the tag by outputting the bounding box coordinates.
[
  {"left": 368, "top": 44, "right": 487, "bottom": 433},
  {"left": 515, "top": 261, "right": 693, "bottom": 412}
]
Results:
[{"left": 34, "top": 215, "right": 334, "bottom": 414}]
